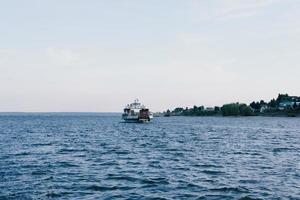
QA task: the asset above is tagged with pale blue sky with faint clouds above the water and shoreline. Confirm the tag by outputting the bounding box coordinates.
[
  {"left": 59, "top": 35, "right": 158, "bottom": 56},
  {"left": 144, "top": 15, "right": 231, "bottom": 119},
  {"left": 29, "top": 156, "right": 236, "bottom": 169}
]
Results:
[{"left": 0, "top": 0, "right": 300, "bottom": 112}]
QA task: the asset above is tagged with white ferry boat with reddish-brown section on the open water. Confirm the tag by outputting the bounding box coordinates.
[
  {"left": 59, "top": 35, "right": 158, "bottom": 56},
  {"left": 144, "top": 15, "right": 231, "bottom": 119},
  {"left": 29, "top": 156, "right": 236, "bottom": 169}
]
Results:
[{"left": 122, "top": 99, "right": 153, "bottom": 122}]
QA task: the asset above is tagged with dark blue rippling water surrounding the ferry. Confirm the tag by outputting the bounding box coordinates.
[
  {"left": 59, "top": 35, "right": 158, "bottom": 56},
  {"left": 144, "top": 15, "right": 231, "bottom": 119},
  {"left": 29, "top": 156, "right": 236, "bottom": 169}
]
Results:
[{"left": 0, "top": 114, "right": 300, "bottom": 200}]
